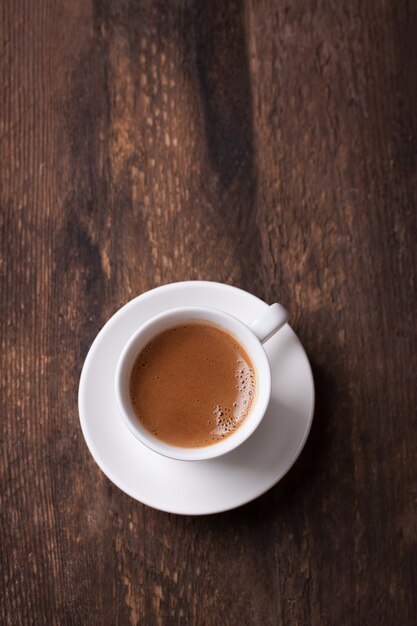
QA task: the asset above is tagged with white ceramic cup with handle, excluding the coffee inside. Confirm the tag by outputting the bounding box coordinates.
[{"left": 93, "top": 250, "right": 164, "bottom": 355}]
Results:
[{"left": 115, "top": 303, "right": 288, "bottom": 461}]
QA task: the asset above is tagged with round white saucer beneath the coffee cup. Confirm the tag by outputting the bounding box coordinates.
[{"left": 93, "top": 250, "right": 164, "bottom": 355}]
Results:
[{"left": 78, "top": 281, "right": 314, "bottom": 515}]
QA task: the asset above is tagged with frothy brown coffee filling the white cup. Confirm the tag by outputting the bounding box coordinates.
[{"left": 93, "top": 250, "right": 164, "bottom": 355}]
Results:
[{"left": 130, "top": 322, "right": 256, "bottom": 448}]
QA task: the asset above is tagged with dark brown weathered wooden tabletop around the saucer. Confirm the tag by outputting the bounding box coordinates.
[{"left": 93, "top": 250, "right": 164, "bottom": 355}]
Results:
[{"left": 0, "top": 0, "right": 417, "bottom": 626}]
